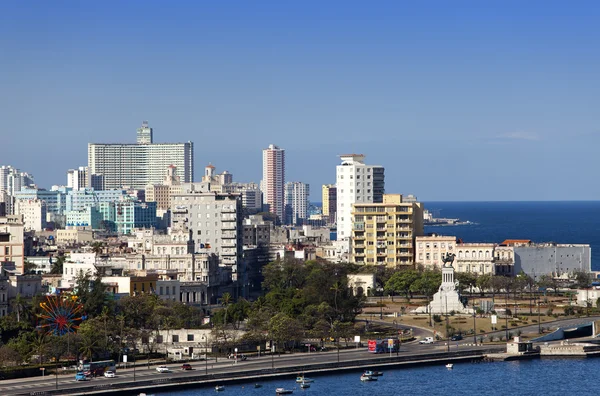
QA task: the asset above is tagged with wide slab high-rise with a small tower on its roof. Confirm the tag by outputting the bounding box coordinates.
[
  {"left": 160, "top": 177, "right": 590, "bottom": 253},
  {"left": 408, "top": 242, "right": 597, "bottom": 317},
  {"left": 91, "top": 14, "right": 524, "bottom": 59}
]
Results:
[{"left": 88, "top": 123, "right": 194, "bottom": 189}]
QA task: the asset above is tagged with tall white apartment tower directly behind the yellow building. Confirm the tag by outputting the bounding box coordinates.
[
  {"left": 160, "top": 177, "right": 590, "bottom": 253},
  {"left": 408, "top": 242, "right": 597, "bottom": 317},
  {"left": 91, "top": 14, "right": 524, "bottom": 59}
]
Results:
[{"left": 336, "top": 154, "right": 385, "bottom": 241}]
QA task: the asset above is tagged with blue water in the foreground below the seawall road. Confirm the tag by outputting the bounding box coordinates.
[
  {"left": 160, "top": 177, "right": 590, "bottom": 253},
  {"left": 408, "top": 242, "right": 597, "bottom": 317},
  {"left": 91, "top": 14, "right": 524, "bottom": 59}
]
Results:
[{"left": 155, "top": 358, "right": 600, "bottom": 396}]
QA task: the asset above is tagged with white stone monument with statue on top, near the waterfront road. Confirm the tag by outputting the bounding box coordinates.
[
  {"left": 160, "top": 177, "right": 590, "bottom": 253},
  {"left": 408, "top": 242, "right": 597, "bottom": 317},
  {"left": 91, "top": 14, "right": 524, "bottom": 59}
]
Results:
[{"left": 414, "top": 253, "right": 473, "bottom": 315}]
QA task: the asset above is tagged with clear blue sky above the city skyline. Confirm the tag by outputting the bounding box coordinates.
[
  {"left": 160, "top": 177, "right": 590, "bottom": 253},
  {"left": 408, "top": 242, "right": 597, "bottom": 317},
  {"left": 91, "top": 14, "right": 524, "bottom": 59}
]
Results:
[{"left": 0, "top": 1, "right": 600, "bottom": 201}]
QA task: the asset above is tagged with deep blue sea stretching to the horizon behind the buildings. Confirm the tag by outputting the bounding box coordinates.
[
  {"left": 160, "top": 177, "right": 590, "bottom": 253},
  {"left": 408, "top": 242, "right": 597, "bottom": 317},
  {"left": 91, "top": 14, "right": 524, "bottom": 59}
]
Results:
[{"left": 423, "top": 201, "right": 600, "bottom": 271}]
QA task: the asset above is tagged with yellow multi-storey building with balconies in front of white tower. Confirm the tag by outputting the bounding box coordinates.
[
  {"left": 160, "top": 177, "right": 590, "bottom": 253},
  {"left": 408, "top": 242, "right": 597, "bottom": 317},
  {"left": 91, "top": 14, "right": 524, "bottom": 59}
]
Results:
[{"left": 351, "top": 194, "right": 423, "bottom": 267}]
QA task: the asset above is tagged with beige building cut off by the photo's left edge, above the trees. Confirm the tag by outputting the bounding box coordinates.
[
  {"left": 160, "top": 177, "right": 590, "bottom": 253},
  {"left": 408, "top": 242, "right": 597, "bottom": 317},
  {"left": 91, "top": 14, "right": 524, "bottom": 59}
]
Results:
[{"left": 0, "top": 215, "right": 25, "bottom": 273}]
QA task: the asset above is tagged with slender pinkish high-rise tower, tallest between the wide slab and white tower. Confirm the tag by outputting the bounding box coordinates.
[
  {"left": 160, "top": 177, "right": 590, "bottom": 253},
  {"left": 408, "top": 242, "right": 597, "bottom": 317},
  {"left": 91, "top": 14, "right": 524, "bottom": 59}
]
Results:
[{"left": 261, "top": 144, "right": 285, "bottom": 221}]
